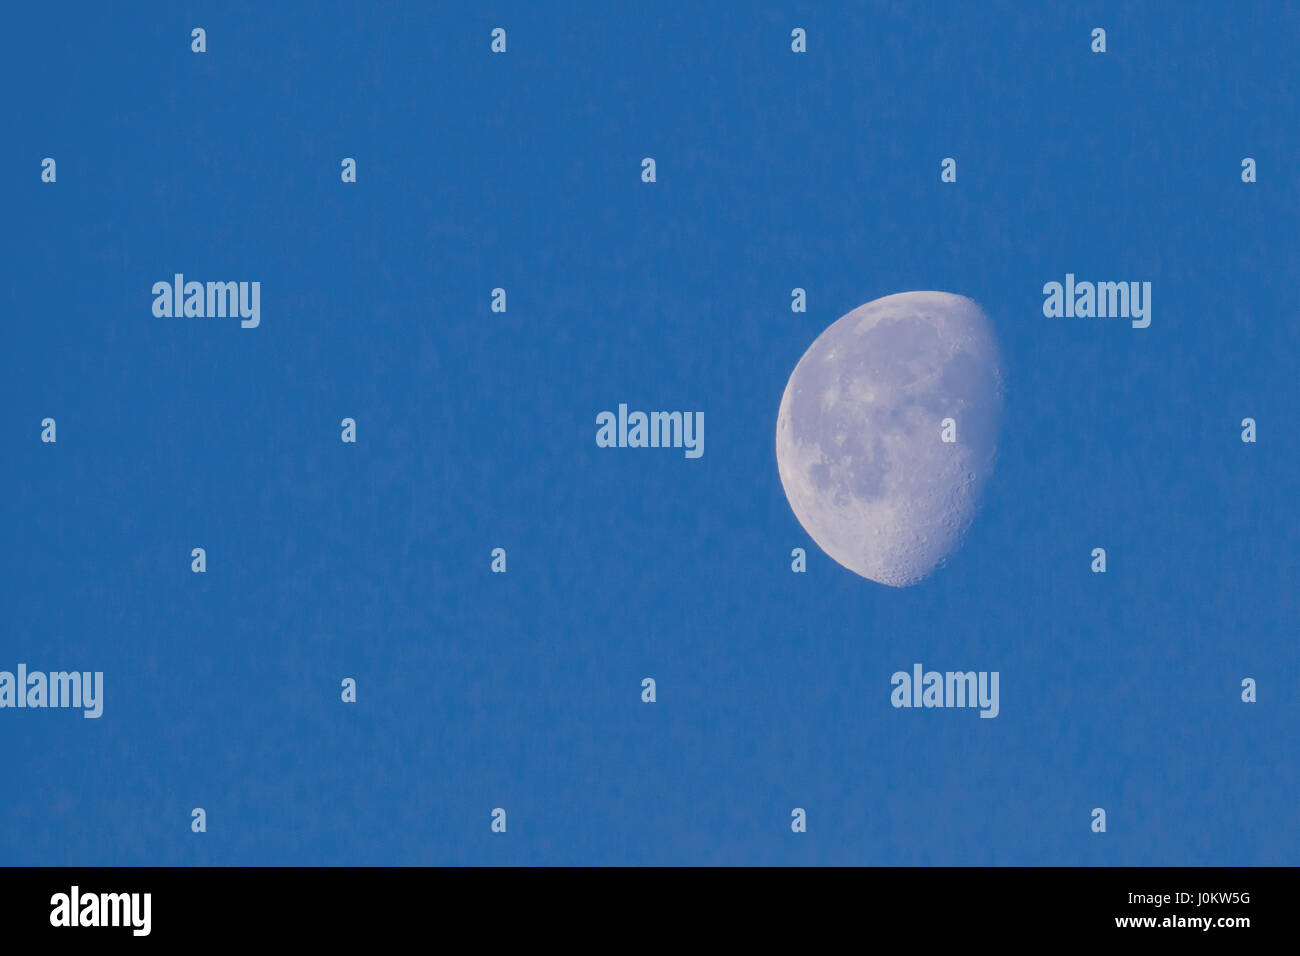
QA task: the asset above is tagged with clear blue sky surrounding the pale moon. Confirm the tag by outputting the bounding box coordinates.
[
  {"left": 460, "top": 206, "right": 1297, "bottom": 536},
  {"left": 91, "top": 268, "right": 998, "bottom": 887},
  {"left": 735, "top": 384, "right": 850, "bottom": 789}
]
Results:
[{"left": 0, "top": 3, "right": 1300, "bottom": 865}]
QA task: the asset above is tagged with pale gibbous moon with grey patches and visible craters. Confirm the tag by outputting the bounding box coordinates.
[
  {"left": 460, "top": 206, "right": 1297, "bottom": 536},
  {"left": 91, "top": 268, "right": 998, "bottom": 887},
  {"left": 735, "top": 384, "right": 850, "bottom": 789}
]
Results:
[{"left": 776, "top": 291, "right": 1002, "bottom": 588}]
